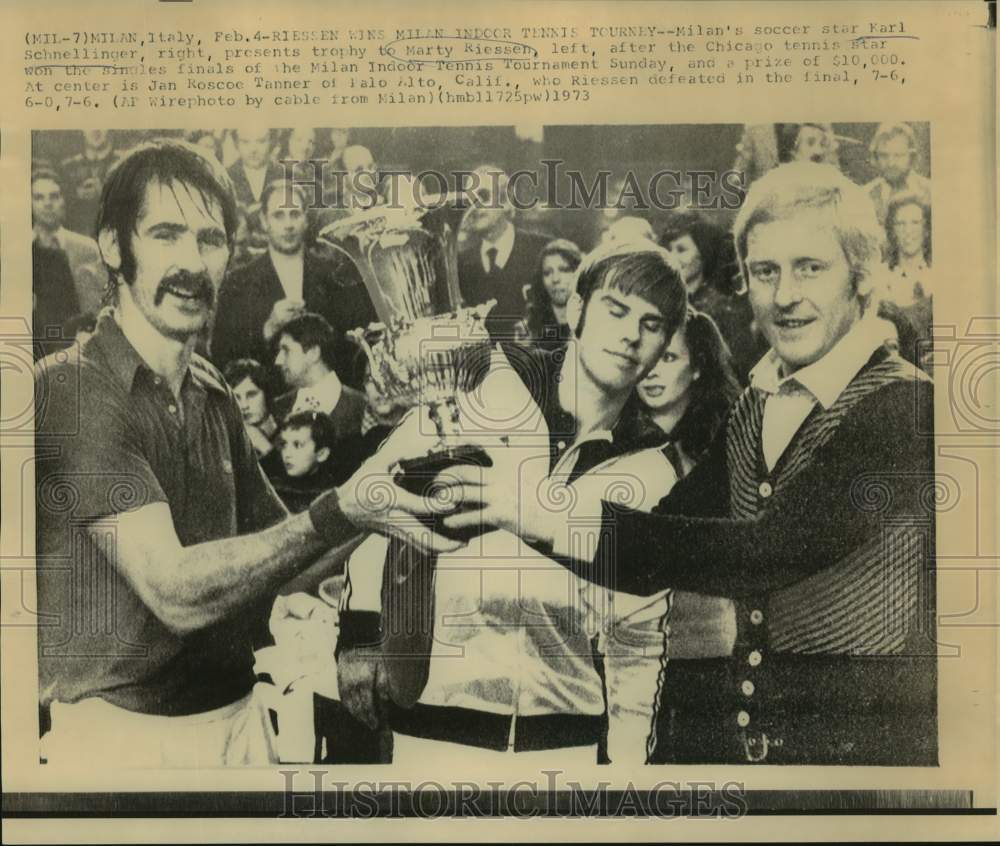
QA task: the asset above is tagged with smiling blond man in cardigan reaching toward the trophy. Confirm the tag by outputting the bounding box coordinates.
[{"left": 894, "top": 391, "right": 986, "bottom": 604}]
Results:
[{"left": 442, "top": 163, "right": 937, "bottom": 765}]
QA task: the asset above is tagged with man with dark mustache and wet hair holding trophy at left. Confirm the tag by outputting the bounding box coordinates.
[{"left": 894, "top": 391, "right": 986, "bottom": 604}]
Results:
[{"left": 35, "top": 140, "right": 454, "bottom": 767}]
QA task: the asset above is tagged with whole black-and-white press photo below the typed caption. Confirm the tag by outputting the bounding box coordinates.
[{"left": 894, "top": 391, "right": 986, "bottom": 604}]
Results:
[{"left": 30, "top": 121, "right": 941, "bottom": 776}]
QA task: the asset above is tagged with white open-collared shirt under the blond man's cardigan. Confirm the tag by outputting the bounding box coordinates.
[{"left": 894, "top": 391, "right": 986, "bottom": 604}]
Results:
[{"left": 750, "top": 312, "right": 885, "bottom": 471}]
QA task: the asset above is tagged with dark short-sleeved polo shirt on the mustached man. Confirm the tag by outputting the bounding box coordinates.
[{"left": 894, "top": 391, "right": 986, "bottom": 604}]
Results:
[{"left": 35, "top": 311, "right": 286, "bottom": 715}]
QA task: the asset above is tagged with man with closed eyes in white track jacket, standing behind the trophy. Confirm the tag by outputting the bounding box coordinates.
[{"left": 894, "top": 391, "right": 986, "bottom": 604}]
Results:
[{"left": 338, "top": 244, "right": 686, "bottom": 764}]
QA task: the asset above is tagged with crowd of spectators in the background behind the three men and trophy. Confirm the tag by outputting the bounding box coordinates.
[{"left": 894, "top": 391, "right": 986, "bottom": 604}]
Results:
[{"left": 31, "top": 123, "right": 934, "bottom": 510}]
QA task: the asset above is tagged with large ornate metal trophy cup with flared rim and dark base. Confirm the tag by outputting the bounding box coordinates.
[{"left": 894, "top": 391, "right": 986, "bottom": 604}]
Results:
[{"left": 318, "top": 195, "right": 495, "bottom": 539}]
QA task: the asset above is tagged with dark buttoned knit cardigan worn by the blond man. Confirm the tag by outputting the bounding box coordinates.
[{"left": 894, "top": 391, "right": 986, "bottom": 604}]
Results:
[{"left": 563, "top": 348, "right": 937, "bottom": 764}]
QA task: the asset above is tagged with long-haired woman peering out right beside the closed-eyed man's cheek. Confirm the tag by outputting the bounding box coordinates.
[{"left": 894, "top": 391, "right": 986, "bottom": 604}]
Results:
[{"left": 638, "top": 308, "right": 740, "bottom": 477}]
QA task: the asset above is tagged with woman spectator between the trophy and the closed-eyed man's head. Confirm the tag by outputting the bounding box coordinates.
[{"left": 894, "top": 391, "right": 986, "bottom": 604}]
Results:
[{"left": 528, "top": 238, "right": 583, "bottom": 350}]
